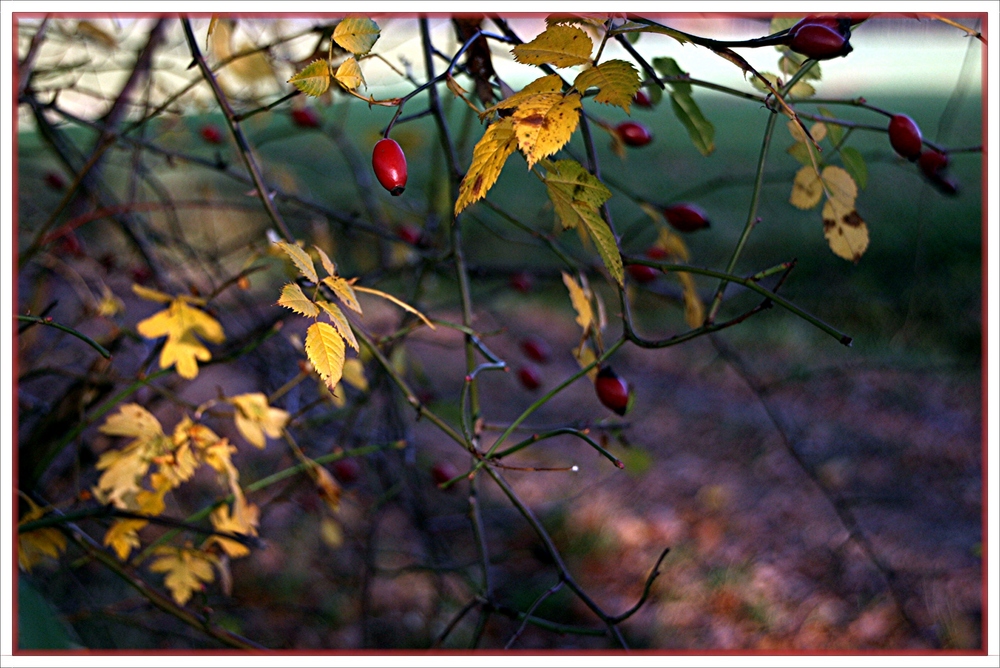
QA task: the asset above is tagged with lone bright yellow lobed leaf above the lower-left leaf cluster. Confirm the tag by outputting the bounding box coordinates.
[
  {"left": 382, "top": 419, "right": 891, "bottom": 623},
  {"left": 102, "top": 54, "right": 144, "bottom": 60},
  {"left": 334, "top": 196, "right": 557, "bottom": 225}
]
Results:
[{"left": 136, "top": 298, "right": 226, "bottom": 379}]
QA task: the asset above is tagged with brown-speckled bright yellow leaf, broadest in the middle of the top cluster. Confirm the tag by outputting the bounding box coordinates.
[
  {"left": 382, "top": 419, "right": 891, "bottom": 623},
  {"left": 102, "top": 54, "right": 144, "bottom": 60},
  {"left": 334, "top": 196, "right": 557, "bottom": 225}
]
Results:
[{"left": 512, "top": 93, "right": 580, "bottom": 169}]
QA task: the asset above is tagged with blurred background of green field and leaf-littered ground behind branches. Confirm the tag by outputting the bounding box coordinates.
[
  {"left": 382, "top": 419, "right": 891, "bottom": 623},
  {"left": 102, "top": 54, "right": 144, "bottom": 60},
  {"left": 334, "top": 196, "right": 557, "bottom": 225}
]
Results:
[{"left": 17, "top": 17, "right": 983, "bottom": 650}]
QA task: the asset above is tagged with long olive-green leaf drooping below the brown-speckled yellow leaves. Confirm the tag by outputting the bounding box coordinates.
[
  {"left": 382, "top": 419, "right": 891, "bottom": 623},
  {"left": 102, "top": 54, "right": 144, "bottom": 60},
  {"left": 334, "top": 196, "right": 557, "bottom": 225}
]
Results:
[{"left": 545, "top": 160, "right": 625, "bottom": 285}]
